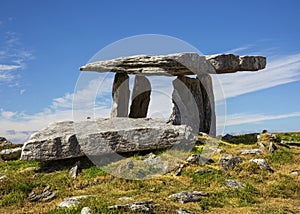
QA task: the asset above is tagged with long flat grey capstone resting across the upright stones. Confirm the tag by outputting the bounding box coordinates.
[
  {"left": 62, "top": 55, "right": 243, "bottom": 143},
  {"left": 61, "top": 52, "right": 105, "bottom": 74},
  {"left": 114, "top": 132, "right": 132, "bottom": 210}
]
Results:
[{"left": 80, "top": 53, "right": 266, "bottom": 76}]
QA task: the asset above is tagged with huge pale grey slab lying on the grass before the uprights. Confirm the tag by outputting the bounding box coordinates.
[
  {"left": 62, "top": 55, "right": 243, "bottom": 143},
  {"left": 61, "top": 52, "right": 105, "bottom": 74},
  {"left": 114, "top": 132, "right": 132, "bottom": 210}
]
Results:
[{"left": 21, "top": 117, "right": 196, "bottom": 161}]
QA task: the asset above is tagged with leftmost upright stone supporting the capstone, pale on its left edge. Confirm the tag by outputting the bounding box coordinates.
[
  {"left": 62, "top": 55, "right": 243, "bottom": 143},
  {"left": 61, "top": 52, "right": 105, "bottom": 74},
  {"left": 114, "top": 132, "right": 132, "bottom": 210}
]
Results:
[{"left": 110, "top": 73, "right": 130, "bottom": 117}]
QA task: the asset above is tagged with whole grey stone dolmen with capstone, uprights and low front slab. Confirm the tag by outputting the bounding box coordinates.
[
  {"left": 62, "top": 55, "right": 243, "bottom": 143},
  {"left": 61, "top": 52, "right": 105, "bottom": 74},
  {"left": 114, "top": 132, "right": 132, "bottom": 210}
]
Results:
[{"left": 21, "top": 53, "right": 266, "bottom": 161}]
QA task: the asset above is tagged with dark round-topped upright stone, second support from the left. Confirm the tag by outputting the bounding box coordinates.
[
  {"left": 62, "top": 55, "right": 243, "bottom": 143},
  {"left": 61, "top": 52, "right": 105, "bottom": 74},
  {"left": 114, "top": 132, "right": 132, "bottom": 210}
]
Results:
[{"left": 129, "top": 76, "right": 151, "bottom": 118}]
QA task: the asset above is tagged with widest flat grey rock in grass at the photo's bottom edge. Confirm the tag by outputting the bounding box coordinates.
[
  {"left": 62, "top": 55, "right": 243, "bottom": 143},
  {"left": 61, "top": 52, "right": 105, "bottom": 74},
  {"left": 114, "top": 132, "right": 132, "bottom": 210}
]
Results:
[{"left": 108, "top": 201, "right": 154, "bottom": 213}]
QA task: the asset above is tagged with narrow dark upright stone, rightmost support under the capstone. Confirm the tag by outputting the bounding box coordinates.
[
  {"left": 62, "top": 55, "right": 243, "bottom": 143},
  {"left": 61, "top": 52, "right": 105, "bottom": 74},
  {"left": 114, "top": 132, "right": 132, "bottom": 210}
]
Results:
[{"left": 198, "top": 74, "right": 216, "bottom": 136}]
